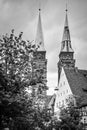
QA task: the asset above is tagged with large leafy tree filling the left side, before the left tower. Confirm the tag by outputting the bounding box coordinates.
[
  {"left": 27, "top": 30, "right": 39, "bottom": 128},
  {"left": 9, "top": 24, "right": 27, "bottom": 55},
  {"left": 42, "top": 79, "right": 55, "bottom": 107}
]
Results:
[{"left": 0, "top": 30, "right": 51, "bottom": 130}]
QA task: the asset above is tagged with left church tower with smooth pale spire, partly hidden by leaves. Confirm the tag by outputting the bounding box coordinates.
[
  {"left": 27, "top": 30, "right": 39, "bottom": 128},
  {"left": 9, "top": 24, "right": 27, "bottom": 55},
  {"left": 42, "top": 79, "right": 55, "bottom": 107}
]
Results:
[{"left": 33, "top": 9, "right": 47, "bottom": 95}]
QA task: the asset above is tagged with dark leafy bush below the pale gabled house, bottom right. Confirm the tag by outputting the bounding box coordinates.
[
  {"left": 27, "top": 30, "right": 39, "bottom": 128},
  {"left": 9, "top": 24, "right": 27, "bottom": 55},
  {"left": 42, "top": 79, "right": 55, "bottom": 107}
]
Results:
[{"left": 60, "top": 100, "right": 82, "bottom": 130}]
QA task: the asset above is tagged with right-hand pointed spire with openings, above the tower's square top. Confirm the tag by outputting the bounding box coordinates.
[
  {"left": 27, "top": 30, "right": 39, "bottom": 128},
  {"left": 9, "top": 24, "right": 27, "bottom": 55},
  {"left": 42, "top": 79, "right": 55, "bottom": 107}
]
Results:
[{"left": 61, "top": 7, "right": 73, "bottom": 52}]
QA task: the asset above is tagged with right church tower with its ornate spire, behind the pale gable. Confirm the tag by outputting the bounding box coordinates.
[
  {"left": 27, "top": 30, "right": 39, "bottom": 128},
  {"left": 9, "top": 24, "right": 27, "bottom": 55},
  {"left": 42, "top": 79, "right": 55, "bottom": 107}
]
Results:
[{"left": 58, "top": 9, "right": 75, "bottom": 82}]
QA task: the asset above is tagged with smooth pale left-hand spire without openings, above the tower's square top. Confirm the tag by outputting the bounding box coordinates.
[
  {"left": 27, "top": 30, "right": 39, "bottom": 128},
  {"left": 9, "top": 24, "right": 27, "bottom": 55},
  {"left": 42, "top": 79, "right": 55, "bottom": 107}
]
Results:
[{"left": 35, "top": 9, "right": 45, "bottom": 51}]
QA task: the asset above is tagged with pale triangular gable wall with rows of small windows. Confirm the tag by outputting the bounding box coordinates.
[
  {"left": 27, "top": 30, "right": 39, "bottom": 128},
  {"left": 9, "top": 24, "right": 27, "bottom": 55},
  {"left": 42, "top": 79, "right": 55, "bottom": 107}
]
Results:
[{"left": 54, "top": 67, "right": 73, "bottom": 112}]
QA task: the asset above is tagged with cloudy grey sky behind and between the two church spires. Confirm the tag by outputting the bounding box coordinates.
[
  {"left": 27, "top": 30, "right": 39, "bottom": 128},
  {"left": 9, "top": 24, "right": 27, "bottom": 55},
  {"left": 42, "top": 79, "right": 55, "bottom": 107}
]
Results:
[{"left": 0, "top": 0, "right": 87, "bottom": 95}]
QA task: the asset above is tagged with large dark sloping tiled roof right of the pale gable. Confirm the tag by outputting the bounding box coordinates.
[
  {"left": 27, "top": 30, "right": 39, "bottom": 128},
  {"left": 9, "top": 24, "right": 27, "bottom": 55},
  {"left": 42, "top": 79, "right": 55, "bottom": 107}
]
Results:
[{"left": 64, "top": 68, "right": 87, "bottom": 104}]
